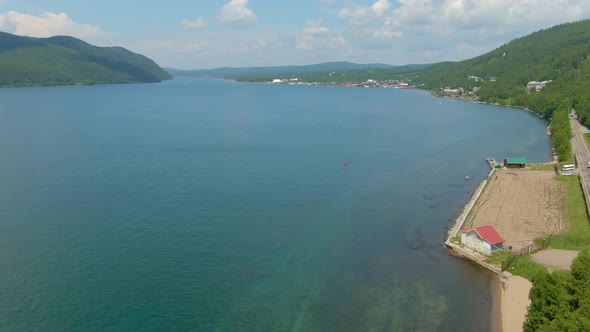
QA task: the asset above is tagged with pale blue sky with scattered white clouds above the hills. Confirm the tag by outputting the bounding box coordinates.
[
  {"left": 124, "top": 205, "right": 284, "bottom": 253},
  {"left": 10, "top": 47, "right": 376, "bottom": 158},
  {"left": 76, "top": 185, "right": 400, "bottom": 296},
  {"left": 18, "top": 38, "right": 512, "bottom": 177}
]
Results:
[{"left": 0, "top": 0, "right": 590, "bottom": 69}]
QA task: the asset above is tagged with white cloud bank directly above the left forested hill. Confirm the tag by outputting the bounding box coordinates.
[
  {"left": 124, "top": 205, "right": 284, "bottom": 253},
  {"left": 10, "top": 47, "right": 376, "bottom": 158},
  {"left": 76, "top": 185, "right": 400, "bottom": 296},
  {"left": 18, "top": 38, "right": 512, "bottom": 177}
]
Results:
[{"left": 0, "top": 11, "right": 109, "bottom": 38}]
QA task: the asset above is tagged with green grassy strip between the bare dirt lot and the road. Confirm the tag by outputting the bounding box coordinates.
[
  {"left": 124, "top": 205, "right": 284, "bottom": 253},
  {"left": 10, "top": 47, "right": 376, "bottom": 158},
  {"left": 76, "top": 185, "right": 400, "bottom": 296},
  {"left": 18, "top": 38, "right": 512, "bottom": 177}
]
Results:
[{"left": 551, "top": 176, "right": 590, "bottom": 249}]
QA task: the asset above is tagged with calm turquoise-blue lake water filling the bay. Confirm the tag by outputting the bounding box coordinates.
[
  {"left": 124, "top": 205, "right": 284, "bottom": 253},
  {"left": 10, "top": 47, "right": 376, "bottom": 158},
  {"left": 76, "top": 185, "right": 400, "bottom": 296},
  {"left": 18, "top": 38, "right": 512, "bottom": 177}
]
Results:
[{"left": 0, "top": 79, "right": 550, "bottom": 331}]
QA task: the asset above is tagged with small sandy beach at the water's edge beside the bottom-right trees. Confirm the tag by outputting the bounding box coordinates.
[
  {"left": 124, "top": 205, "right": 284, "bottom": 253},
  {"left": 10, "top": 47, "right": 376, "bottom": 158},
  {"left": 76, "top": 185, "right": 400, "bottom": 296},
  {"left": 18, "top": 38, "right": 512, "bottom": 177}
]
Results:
[{"left": 491, "top": 276, "right": 533, "bottom": 332}]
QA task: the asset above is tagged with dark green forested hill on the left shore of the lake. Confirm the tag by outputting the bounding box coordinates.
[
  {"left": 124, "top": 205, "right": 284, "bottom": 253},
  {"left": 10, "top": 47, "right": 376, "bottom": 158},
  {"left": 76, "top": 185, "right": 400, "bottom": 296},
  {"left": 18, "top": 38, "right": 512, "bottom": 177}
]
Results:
[{"left": 0, "top": 32, "right": 172, "bottom": 87}]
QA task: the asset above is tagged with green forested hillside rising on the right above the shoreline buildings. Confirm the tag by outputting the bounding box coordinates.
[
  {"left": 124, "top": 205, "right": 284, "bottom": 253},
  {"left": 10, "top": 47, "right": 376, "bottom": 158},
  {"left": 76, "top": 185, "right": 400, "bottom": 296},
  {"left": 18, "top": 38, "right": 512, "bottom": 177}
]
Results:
[{"left": 416, "top": 20, "right": 590, "bottom": 120}]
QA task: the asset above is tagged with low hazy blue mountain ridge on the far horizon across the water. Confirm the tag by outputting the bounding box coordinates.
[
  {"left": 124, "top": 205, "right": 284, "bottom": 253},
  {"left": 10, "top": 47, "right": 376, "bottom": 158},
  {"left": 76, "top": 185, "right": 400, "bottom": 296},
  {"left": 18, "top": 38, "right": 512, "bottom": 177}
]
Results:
[{"left": 166, "top": 62, "right": 395, "bottom": 79}]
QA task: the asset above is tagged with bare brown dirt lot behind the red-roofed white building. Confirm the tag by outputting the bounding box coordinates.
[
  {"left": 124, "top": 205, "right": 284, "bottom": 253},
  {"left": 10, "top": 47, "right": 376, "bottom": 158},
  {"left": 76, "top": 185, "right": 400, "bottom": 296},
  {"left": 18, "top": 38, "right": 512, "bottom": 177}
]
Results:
[{"left": 464, "top": 169, "right": 567, "bottom": 250}]
